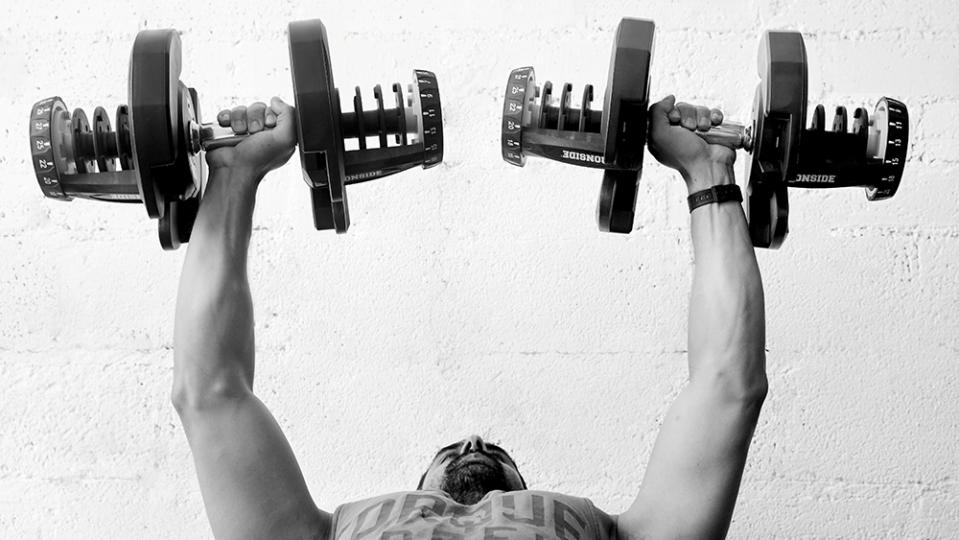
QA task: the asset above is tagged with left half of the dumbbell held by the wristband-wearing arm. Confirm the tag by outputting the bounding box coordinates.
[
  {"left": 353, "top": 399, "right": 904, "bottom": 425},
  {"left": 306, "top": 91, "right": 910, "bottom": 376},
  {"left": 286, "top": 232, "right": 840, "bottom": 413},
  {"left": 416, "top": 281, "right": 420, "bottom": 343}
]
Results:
[{"left": 501, "top": 19, "right": 653, "bottom": 233}]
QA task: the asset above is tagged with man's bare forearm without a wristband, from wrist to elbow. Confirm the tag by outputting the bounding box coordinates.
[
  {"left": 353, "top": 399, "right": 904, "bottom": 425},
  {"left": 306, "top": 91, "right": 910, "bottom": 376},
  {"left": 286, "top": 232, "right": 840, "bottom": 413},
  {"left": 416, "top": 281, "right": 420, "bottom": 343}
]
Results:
[{"left": 174, "top": 168, "right": 258, "bottom": 401}]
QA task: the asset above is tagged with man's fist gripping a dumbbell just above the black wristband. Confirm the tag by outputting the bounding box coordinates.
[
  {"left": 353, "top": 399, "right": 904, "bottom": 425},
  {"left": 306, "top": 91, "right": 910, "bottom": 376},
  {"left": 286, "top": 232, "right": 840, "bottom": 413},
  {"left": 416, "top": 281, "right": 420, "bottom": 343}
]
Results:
[{"left": 647, "top": 96, "right": 736, "bottom": 193}]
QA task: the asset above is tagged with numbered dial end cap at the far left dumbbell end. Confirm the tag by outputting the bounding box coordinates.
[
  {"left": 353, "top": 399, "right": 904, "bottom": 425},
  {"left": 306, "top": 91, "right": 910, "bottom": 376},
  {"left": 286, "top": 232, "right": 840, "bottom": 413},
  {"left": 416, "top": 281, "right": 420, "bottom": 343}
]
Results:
[{"left": 30, "top": 97, "right": 75, "bottom": 201}]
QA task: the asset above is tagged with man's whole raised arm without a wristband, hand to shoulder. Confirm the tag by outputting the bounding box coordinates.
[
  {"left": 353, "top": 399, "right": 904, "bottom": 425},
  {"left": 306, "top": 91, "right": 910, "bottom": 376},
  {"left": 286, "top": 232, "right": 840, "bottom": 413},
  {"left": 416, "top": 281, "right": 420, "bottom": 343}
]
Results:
[{"left": 173, "top": 100, "right": 330, "bottom": 539}]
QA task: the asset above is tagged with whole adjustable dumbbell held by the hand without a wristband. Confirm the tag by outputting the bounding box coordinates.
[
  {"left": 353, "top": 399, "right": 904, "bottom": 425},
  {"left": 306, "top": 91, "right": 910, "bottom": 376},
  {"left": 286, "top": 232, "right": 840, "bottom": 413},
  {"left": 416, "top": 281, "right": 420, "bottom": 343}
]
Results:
[{"left": 30, "top": 20, "right": 443, "bottom": 249}]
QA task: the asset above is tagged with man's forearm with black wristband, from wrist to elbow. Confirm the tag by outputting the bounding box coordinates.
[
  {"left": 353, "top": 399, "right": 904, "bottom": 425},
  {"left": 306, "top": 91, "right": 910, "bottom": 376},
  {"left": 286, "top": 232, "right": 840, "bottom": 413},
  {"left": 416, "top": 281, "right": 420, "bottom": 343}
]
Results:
[{"left": 689, "top": 169, "right": 766, "bottom": 398}]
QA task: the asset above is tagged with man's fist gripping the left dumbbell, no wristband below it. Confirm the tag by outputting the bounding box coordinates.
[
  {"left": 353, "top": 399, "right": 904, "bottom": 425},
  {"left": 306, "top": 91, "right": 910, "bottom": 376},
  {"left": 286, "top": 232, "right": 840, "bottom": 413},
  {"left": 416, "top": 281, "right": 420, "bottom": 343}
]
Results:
[{"left": 206, "top": 97, "right": 297, "bottom": 179}]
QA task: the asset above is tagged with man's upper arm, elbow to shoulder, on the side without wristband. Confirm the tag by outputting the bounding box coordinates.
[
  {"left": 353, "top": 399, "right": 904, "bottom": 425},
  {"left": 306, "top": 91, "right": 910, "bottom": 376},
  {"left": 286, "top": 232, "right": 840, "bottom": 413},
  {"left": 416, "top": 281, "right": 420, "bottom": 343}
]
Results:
[{"left": 179, "top": 393, "right": 331, "bottom": 539}]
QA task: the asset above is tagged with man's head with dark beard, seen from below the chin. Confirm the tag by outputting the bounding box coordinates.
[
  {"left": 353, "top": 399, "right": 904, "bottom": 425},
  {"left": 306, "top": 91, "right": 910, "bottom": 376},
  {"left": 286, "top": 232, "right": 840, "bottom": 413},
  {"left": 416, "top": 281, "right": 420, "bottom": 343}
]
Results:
[{"left": 416, "top": 435, "right": 526, "bottom": 505}]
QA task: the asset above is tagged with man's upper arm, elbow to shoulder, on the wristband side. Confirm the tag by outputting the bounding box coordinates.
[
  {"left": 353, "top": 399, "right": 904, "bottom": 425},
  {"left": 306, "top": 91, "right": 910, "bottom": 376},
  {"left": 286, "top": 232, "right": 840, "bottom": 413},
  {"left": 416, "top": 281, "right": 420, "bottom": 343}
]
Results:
[{"left": 618, "top": 383, "right": 761, "bottom": 538}]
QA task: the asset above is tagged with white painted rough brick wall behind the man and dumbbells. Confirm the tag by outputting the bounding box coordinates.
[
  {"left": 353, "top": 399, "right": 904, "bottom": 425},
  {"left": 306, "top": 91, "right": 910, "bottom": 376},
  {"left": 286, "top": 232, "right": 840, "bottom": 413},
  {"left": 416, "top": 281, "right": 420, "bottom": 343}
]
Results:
[{"left": 0, "top": 0, "right": 959, "bottom": 539}]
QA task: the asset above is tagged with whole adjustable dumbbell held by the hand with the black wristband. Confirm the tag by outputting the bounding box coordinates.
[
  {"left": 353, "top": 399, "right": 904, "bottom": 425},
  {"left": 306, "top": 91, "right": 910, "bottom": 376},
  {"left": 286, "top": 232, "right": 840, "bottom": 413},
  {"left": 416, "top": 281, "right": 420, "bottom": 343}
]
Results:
[{"left": 502, "top": 19, "right": 908, "bottom": 248}]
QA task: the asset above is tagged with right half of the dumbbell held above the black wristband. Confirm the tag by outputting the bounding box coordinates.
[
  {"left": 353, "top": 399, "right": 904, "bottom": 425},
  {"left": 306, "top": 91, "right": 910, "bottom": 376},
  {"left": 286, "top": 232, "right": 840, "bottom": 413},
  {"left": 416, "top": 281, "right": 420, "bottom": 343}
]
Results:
[{"left": 697, "top": 31, "right": 909, "bottom": 248}]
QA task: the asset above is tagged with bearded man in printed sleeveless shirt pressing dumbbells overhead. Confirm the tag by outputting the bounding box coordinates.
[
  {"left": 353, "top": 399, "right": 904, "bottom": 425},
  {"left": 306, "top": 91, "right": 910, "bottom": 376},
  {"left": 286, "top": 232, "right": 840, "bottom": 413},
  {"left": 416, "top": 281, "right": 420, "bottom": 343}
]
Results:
[{"left": 173, "top": 97, "right": 766, "bottom": 540}]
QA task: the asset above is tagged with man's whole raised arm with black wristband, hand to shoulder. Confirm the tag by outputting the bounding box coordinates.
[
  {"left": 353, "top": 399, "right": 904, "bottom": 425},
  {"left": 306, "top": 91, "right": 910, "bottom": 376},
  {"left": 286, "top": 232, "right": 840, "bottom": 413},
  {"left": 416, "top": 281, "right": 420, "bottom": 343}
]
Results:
[{"left": 619, "top": 97, "right": 766, "bottom": 538}]
